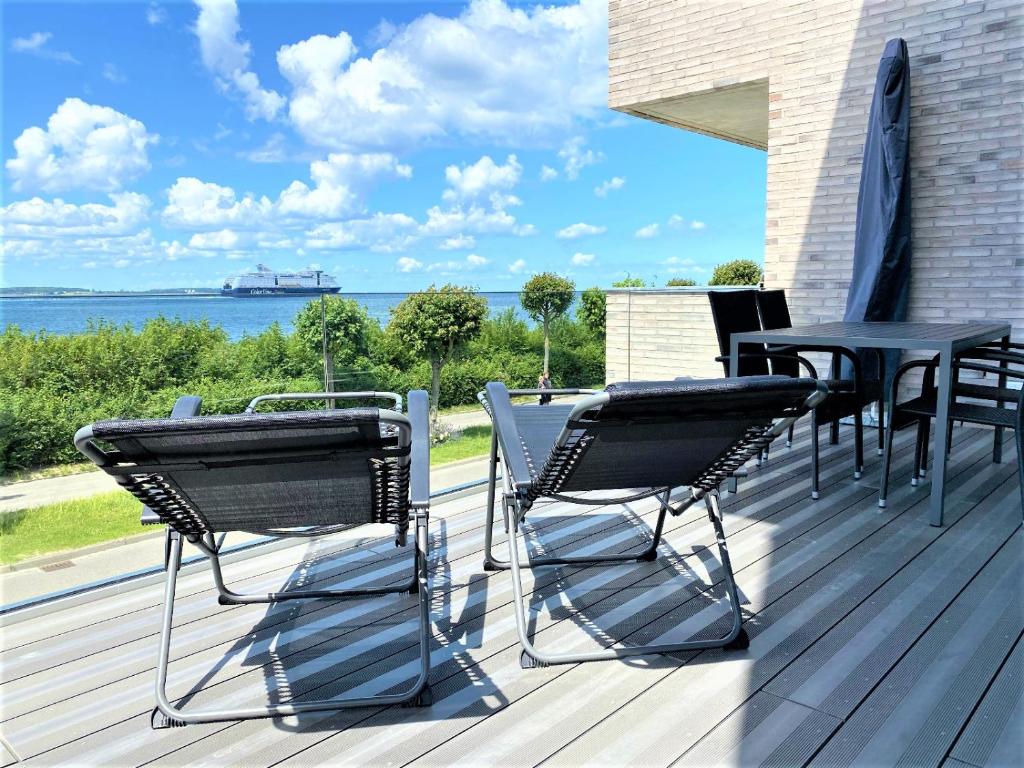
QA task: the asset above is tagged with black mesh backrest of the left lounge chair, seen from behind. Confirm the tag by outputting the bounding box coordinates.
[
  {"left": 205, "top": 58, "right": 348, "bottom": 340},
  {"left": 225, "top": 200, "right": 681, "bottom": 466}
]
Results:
[{"left": 86, "top": 415, "right": 409, "bottom": 534}]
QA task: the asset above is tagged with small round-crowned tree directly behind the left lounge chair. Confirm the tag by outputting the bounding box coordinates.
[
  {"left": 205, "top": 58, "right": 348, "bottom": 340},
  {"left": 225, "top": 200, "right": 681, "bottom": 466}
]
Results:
[{"left": 295, "top": 296, "right": 374, "bottom": 388}]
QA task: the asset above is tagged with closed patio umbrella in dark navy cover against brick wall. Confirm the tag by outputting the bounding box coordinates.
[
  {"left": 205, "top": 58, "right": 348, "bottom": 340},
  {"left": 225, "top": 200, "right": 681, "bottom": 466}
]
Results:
[{"left": 843, "top": 38, "right": 910, "bottom": 393}]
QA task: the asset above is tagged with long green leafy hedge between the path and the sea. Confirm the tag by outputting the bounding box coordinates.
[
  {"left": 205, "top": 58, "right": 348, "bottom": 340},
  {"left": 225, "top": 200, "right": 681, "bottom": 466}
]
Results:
[{"left": 0, "top": 303, "right": 604, "bottom": 474}]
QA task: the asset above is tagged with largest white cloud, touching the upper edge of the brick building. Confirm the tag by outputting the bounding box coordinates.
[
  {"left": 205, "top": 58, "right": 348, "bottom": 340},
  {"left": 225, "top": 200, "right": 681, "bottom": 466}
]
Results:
[{"left": 278, "top": 0, "right": 607, "bottom": 148}]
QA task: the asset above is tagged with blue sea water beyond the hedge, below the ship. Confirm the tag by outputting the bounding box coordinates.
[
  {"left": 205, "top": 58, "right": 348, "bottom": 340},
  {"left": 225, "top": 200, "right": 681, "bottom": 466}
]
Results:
[{"left": 0, "top": 292, "right": 561, "bottom": 339}]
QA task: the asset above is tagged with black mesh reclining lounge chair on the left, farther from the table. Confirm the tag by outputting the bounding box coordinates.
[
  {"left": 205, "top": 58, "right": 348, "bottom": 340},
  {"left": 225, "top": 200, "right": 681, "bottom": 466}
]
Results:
[{"left": 75, "top": 391, "right": 430, "bottom": 728}]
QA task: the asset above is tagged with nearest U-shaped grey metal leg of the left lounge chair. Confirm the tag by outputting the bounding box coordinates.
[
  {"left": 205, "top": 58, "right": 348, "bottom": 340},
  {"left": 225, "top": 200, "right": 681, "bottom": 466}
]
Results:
[{"left": 151, "top": 528, "right": 431, "bottom": 728}]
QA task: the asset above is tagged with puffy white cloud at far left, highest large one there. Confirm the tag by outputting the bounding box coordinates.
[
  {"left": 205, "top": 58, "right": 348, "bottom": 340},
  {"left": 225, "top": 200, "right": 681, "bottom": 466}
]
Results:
[{"left": 6, "top": 98, "right": 159, "bottom": 191}]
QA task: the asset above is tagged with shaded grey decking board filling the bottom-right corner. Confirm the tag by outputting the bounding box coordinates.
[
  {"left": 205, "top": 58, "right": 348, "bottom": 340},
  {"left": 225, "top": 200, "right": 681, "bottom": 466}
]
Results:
[{"left": 949, "top": 639, "right": 1024, "bottom": 767}]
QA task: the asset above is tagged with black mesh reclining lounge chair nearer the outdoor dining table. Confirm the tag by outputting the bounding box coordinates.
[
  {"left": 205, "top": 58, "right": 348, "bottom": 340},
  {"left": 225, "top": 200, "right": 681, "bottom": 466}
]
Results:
[{"left": 479, "top": 376, "right": 826, "bottom": 668}]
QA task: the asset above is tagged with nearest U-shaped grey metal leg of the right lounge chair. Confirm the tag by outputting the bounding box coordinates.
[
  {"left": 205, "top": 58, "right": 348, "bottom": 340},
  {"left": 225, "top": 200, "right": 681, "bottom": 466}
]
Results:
[{"left": 509, "top": 490, "right": 750, "bottom": 669}]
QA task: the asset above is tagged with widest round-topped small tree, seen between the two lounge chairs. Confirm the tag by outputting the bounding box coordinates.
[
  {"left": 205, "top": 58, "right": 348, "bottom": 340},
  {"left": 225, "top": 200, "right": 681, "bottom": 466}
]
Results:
[{"left": 388, "top": 285, "right": 487, "bottom": 420}]
